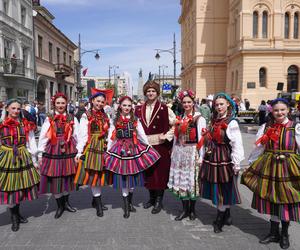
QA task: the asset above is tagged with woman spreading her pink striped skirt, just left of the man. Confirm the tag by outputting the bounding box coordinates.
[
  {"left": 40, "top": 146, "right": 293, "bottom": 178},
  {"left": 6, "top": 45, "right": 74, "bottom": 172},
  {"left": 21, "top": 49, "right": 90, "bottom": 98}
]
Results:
[{"left": 105, "top": 96, "right": 160, "bottom": 218}]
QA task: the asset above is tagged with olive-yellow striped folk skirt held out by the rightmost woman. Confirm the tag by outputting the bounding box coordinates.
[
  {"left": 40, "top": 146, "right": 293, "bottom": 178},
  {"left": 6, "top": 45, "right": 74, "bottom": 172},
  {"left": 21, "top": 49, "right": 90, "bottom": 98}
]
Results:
[{"left": 241, "top": 151, "right": 300, "bottom": 222}]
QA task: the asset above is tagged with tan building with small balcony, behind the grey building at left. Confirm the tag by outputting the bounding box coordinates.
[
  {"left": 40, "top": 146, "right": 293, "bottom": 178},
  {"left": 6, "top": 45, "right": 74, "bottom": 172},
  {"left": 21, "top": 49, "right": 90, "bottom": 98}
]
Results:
[{"left": 33, "top": 1, "right": 77, "bottom": 110}]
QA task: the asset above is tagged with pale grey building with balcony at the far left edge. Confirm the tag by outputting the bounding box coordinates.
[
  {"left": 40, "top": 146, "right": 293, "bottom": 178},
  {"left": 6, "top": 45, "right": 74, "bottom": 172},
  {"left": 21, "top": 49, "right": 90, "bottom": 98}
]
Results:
[{"left": 0, "top": 0, "right": 36, "bottom": 101}]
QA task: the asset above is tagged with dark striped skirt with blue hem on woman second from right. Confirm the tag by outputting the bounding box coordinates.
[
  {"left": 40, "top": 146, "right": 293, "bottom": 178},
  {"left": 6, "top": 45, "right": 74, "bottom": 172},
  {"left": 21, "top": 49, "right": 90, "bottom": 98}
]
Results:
[{"left": 199, "top": 143, "right": 241, "bottom": 206}]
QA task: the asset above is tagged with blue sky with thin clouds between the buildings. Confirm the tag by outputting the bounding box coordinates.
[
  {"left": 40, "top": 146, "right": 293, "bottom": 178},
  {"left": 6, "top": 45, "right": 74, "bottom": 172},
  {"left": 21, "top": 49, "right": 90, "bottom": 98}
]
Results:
[{"left": 41, "top": 0, "right": 181, "bottom": 92}]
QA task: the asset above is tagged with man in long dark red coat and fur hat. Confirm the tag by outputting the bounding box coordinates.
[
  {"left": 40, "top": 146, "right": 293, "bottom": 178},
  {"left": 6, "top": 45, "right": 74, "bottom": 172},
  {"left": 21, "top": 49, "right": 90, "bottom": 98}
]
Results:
[{"left": 135, "top": 80, "right": 176, "bottom": 214}]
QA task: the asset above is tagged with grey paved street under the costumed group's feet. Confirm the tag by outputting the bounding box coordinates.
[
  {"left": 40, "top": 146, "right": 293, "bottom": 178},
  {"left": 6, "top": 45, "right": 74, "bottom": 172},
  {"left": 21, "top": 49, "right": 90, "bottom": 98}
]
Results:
[{"left": 0, "top": 125, "right": 300, "bottom": 250}]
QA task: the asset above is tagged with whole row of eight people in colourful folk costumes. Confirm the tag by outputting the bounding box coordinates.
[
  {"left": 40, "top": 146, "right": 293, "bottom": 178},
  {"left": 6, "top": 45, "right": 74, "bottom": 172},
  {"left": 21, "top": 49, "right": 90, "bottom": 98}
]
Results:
[{"left": 0, "top": 80, "right": 300, "bottom": 249}]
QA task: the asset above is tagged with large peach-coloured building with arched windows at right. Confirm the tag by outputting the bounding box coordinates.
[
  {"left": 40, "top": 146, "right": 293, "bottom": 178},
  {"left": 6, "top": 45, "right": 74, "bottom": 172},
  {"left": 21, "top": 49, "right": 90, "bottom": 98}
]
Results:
[{"left": 179, "top": 0, "right": 300, "bottom": 106}]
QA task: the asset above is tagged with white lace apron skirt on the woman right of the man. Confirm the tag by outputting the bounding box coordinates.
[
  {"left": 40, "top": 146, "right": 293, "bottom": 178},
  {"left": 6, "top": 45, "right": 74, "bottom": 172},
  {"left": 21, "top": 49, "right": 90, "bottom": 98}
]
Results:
[{"left": 168, "top": 145, "right": 199, "bottom": 199}]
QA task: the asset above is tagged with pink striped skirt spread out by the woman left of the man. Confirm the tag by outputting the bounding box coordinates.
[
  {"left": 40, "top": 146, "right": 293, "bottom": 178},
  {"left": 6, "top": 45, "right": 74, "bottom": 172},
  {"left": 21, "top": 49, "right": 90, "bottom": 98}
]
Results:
[{"left": 104, "top": 138, "right": 160, "bottom": 188}]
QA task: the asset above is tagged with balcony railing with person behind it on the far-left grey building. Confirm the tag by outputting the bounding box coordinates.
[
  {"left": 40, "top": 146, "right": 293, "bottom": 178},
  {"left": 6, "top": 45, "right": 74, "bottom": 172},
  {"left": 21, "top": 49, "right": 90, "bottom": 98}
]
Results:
[{"left": 0, "top": 58, "right": 25, "bottom": 76}]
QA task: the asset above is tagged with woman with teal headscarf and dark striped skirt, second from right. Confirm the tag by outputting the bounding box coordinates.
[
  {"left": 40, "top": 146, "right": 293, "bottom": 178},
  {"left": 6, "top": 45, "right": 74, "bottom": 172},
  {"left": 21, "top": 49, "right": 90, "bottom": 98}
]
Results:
[{"left": 199, "top": 93, "right": 244, "bottom": 233}]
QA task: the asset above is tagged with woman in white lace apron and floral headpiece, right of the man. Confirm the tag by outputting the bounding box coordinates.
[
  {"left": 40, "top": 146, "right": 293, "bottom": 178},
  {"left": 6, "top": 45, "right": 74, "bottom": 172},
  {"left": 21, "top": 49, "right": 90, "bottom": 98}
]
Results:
[{"left": 168, "top": 90, "right": 206, "bottom": 221}]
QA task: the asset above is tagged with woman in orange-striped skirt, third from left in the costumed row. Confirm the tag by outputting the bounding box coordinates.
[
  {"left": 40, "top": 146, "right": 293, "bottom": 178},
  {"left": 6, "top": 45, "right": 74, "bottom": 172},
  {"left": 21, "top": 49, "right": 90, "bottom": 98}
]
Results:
[{"left": 75, "top": 89, "right": 113, "bottom": 217}]
